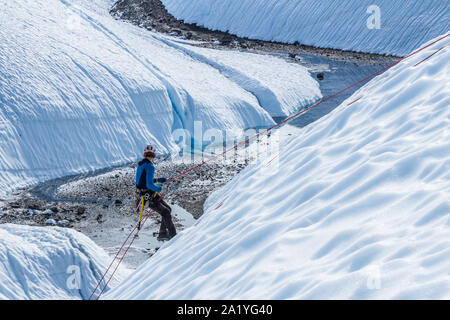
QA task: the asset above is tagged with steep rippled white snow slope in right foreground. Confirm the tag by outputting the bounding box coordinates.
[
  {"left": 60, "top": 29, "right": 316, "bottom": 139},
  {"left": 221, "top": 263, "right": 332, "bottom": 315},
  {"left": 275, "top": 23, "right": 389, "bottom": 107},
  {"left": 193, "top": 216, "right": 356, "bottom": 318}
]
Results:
[{"left": 105, "top": 36, "right": 450, "bottom": 299}]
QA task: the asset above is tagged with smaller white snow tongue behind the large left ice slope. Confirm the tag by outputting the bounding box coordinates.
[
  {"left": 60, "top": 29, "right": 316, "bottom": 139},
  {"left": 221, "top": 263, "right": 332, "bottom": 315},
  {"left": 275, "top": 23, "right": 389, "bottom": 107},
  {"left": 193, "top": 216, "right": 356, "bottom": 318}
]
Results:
[{"left": 158, "top": 41, "right": 320, "bottom": 116}]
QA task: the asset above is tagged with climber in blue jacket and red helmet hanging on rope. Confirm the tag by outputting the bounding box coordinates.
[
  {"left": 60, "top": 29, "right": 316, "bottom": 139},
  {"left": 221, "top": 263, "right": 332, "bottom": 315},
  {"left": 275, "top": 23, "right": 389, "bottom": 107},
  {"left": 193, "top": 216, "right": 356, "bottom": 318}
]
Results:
[{"left": 136, "top": 145, "right": 177, "bottom": 241}]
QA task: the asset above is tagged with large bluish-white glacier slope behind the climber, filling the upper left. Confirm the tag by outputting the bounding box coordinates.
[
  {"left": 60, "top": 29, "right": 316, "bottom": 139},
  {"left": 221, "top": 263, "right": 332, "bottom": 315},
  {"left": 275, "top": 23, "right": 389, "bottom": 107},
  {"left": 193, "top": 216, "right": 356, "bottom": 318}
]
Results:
[{"left": 0, "top": 0, "right": 321, "bottom": 194}]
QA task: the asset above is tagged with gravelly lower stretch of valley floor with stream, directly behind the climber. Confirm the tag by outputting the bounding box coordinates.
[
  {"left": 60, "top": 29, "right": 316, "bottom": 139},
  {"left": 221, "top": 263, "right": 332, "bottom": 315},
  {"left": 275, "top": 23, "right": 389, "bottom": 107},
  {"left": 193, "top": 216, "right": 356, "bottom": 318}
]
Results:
[{"left": 0, "top": 125, "right": 301, "bottom": 269}]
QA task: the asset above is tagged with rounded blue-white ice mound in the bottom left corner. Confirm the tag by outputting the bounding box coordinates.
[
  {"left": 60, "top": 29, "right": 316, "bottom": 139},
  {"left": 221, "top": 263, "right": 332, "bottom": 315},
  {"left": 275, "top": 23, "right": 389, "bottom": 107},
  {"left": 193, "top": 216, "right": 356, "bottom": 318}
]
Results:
[{"left": 0, "top": 224, "right": 129, "bottom": 300}]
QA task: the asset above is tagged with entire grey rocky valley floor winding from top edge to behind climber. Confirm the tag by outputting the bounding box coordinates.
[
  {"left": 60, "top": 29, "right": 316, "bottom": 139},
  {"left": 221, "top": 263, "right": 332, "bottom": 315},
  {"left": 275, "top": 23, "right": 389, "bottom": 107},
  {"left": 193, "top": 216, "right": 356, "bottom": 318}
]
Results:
[{"left": 0, "top": 0, "right": 395, "bottom": 268}]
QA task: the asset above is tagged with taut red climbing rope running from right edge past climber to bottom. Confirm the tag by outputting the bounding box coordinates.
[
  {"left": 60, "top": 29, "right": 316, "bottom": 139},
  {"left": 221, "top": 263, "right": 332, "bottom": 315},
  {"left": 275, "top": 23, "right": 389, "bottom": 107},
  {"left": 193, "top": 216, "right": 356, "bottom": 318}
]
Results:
[{"left": 89, "top": 34, "right": 450, "bottom": 300}]
